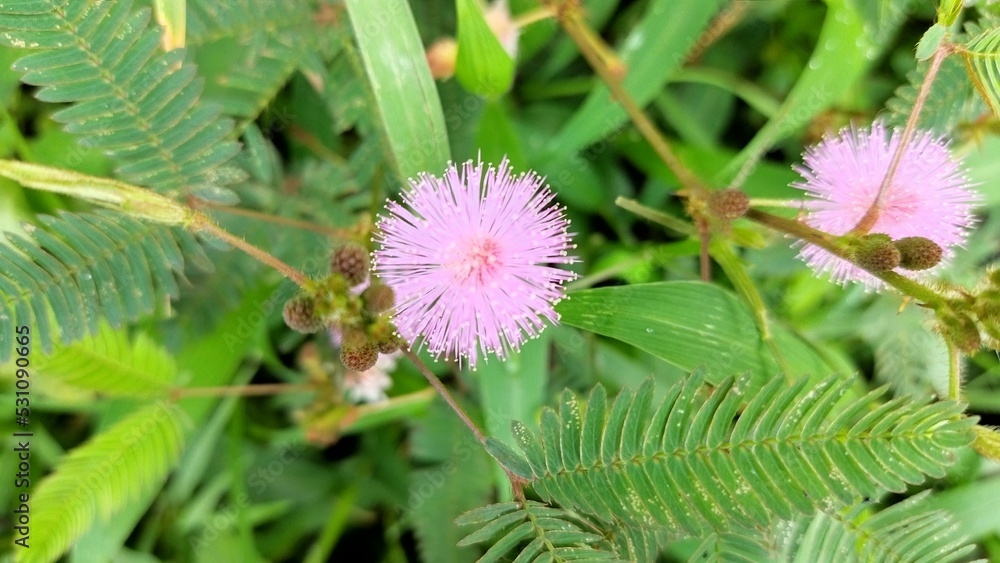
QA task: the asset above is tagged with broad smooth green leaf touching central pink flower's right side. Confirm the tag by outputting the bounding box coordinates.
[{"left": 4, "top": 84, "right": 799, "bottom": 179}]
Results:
[{"left": 556, "top": 282, "right": 771, "bottom": 384}]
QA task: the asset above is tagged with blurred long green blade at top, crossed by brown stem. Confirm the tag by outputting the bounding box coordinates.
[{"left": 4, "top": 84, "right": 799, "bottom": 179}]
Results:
[{"left": 550, "top": 0, "right": 722, "bottom": 157}]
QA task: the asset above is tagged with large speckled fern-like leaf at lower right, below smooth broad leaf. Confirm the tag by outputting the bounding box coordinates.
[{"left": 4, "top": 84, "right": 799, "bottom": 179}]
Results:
[{"left": 504, "top": 373, "right": 975, "bottom": 537}]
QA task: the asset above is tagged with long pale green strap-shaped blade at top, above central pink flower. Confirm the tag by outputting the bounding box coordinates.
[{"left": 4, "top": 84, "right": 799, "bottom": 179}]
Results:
[{"left": 346, "top": 0, "right": 449, "bottom": 179}]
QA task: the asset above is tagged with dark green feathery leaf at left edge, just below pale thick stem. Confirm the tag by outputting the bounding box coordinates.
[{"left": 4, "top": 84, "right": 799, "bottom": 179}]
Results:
[{"left": 0, "top": 213, "right": 211, "bottom": 361}]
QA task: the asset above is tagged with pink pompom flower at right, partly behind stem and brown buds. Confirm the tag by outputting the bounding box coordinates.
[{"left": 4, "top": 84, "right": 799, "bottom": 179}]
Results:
[{"left": 792, "top": 122, "right": 977, "bottom": 289}]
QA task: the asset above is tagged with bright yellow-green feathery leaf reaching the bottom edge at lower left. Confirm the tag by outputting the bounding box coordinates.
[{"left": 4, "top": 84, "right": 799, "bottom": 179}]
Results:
[{"left": 18, "top": 403, "right": 184, "bottom": 563}]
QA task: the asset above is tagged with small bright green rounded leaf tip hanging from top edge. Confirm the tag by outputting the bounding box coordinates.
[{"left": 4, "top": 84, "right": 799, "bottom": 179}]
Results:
[{"left": 455, "top": 0, "right": 514, "bottom": 98}]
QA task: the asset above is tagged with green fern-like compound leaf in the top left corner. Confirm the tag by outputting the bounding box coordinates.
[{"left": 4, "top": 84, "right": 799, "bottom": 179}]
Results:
[{"left": 0, "top": 0, "right": 241, "bottom": 198}]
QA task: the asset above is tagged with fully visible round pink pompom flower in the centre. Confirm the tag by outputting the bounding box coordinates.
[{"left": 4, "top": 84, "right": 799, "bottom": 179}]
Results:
[{"left": 374, "top": 158, "right": 576, "bottom": 369}]
